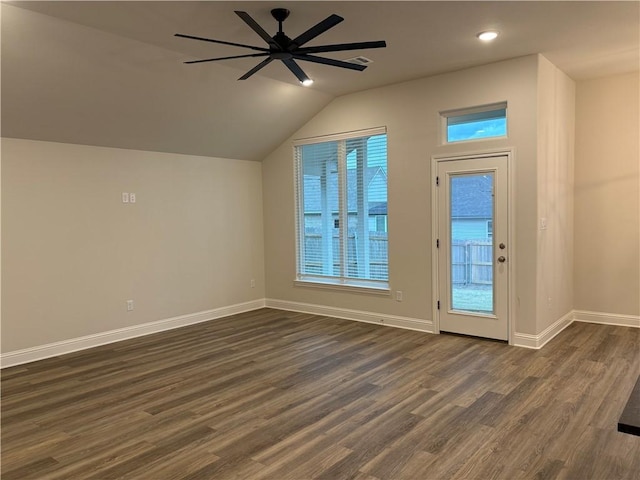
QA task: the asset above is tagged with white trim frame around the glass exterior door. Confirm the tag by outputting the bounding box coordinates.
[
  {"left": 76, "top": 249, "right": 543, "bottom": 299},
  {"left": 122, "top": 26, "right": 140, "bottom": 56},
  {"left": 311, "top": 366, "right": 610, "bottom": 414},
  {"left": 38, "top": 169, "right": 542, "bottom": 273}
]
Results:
[{"left": 431, "top": 147, "right": 517, "bottom": 345}]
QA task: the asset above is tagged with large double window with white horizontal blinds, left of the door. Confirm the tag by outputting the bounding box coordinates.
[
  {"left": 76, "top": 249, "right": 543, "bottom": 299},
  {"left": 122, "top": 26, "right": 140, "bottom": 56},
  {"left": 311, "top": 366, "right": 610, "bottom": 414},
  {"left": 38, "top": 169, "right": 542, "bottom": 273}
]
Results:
[{"left": 295, "top": 128, "right": 389, "bottom": 290}]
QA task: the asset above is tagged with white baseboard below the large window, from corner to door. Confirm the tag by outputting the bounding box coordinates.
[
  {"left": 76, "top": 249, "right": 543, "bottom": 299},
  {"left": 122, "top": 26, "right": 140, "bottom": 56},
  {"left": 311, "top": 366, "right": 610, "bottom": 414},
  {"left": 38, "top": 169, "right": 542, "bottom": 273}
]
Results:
[{"left": 265, "top": 298, "right": 434, "bottom": 333}]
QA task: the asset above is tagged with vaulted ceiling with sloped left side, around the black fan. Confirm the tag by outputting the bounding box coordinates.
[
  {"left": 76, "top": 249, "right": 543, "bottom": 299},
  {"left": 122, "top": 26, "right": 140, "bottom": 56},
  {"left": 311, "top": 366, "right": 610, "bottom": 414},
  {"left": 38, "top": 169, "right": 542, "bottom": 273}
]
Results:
[{"left": 1, "top": 1, "right": 640, "bottom": 160}]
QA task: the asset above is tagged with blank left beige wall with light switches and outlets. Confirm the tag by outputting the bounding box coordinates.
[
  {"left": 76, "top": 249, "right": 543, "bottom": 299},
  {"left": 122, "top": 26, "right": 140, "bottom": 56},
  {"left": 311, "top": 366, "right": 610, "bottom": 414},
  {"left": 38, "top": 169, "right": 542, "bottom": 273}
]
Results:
[{"left": 2, "top": 138, "right": 265, "bottom": 353}]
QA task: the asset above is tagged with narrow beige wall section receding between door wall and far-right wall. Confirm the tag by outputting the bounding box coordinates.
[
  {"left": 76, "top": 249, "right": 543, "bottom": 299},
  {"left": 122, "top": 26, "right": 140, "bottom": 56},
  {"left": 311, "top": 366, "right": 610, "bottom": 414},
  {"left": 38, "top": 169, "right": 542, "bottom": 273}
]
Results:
[{"left": 536, "top": 52, "right": 575, "bottom": 332}]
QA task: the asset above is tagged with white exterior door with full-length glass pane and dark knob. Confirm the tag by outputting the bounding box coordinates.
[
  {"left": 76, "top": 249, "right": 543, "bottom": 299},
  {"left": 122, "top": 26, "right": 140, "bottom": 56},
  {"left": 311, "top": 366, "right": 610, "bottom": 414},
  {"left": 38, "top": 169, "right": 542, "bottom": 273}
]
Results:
[{"left": 436, "top": 155, "right": 509, "bottom": 340}]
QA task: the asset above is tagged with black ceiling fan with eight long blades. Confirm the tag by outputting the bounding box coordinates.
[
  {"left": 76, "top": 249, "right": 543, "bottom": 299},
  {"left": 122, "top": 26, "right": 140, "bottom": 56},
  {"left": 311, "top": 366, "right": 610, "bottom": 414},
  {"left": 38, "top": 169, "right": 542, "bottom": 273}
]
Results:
[{"left": 175, "top": 8, "right": 387, "bottom": 85}]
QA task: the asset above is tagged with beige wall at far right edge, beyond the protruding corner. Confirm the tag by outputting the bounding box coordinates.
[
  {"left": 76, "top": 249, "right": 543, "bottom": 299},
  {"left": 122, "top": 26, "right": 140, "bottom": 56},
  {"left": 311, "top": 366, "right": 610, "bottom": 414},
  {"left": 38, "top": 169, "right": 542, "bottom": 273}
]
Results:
[{"left": 574, "top": 73, "right": 640, "bottom": 315}]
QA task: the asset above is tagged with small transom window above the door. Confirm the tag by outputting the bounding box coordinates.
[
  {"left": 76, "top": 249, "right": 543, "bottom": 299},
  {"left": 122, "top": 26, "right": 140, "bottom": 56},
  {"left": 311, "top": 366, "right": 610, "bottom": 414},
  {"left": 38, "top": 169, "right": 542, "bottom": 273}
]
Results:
[{"left": 440, "top": 103, "right": 507, "bottom": 143}]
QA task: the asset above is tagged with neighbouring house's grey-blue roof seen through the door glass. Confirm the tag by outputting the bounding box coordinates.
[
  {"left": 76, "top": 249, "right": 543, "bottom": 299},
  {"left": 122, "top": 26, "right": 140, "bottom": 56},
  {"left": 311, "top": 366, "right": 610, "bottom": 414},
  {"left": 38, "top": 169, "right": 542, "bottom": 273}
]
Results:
[{"left": 451, "top": 175, "right": 493, "bottom": 218}]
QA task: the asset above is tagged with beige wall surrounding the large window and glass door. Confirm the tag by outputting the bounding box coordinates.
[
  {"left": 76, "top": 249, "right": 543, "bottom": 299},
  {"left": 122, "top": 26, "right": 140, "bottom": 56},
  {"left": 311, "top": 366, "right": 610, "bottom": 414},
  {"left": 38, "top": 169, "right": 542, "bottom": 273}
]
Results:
[{"left": 263, "top": 55, "right": 538, "bottom": 334}]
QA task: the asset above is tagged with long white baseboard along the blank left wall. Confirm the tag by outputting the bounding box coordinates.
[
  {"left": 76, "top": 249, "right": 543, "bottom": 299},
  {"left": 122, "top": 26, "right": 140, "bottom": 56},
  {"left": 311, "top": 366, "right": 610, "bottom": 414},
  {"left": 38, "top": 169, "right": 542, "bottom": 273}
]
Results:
[{"left": 0, "top": 299, "right": 265, "bottom": 368}]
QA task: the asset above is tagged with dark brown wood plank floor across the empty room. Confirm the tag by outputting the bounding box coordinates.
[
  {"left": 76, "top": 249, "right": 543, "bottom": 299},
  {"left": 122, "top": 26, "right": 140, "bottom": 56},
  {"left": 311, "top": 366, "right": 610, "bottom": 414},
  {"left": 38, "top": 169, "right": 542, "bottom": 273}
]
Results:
[{"left": 2, "top": 309, "right": 640, "bottom": 480}]
